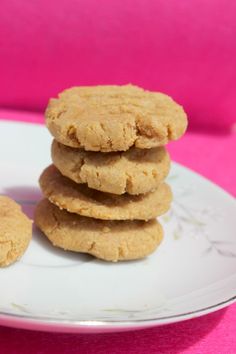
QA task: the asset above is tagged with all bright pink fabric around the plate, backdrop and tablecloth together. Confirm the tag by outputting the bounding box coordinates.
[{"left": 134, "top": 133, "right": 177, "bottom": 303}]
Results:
[{"left": 0, "top": 0, "right": 236, "bottom": 354}]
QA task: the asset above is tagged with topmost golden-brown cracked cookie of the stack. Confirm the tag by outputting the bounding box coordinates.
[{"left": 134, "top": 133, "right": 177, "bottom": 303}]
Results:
[{"left": 45, "top": 85, "right": 187, "bottom": 152}]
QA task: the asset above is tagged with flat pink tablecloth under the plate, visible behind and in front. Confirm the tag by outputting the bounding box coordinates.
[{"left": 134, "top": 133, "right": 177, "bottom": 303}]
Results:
[{"left": 0, "top": 111, "right": 236, "bottom": 354}]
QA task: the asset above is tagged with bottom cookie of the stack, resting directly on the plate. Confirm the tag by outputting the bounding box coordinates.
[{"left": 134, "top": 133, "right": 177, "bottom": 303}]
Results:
[{"left": 35, "top": 199, "right": 163, "bottom": 262}]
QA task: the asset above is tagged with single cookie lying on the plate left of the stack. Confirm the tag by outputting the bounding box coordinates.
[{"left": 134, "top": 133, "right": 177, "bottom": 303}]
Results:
[{"left": 0, "top": 196, "right": 32, "bottom": 267}]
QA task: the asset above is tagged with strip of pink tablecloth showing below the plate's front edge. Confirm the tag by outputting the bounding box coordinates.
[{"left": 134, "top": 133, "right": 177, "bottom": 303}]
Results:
[{"left": 0, "top": 305, "right": 236, "bottom": 354}]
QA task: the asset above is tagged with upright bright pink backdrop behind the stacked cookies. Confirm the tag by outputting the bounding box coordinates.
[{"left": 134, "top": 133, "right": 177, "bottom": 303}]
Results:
[{"left": 0, "top": 0, "right": 236, "bottom": 129}]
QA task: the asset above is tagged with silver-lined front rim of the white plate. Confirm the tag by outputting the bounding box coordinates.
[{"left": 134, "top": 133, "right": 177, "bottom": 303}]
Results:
[{"left": 0, "top": 294, "right": 236, "bottom": 333}]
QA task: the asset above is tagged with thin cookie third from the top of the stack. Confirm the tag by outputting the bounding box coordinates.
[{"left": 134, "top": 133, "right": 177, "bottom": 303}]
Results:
[{"left": 39, "top": 165, "right": 172, "bottom": 220}]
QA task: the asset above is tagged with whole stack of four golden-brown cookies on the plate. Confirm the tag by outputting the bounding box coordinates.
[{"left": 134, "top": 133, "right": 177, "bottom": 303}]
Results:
[{"left": 35, "top": 85, "right": 187, "bottom": 261}]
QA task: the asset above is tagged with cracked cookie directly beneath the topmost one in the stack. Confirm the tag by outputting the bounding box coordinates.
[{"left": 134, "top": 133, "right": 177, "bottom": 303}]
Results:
[{"left": 51, "top": 140, "right": 170, "bottom": 194}]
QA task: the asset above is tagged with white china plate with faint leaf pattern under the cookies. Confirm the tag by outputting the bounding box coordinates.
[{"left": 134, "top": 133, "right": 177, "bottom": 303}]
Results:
[{"left": 0, "top": 121, "right": 236, "bottom": 332}]
